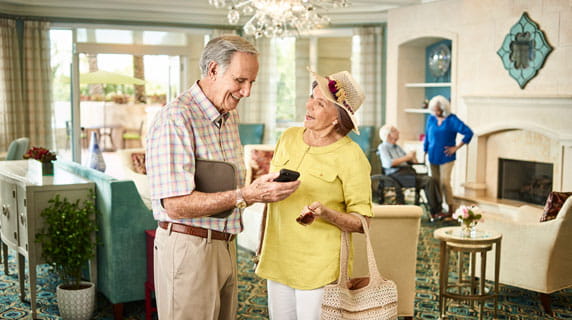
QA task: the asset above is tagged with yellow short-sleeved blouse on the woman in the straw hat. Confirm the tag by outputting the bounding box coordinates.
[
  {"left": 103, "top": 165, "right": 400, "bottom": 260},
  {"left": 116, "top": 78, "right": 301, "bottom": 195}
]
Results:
[{"left": 256, "top": 128, "right": 373, "bottom": 290}]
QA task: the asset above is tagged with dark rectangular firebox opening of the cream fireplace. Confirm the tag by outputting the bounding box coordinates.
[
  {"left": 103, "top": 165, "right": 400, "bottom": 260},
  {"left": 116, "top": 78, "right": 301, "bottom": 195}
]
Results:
[{"left": 497, "top": 158, "right": 553, "bottom": 205}]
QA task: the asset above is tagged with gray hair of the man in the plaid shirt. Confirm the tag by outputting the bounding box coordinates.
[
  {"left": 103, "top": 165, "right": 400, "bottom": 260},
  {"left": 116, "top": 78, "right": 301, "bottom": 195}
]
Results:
[{"left": 199, "top": 35, "right": 258, "bottom": 77}]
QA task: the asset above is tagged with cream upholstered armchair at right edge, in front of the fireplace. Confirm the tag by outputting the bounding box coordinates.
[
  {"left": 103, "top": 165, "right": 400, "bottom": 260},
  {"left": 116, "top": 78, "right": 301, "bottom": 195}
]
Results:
[{"left": 476, "top": 197, "right": 572, "bottom": 313}]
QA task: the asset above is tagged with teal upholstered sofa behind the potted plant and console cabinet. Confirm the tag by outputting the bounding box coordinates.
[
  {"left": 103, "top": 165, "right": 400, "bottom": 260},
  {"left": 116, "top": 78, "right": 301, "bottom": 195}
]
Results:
[{"left": 56, "top": 160, "right": 157, "bottom": 319}]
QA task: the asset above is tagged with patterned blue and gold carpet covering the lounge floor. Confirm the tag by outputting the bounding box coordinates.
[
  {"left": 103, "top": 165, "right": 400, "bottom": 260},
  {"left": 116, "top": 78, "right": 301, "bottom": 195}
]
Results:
[{"left": 0, "top": 216, "right": 572, "bottom": 320}]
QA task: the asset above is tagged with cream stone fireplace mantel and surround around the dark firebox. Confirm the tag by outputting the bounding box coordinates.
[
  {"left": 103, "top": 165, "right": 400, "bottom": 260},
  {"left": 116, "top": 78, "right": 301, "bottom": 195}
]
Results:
[{"left": 459, "top": 95, "right": 572, "bottom": 197}]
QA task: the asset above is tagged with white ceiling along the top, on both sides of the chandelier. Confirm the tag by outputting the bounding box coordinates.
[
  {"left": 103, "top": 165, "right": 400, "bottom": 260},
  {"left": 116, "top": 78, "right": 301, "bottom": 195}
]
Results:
[{"left": 0, "top": 0, "right": 432, "bottom": 26}]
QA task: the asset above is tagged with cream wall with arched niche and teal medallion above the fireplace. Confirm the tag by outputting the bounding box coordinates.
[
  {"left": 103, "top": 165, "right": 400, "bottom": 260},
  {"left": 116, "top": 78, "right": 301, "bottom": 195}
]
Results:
[{"left": 386, "top": 0, "right": 572, "bottom": 196}]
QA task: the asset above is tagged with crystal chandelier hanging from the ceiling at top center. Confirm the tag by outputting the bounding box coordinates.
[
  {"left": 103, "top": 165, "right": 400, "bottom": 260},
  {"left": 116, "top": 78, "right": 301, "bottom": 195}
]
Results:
[{"left": 209, "top": 0, "right": 350, "bottom": 38}]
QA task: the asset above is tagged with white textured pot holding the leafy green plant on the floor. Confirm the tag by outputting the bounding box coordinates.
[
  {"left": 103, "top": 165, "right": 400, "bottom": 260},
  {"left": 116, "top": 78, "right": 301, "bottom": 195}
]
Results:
[{"left": 56, "top": 281, "right": 95, "bottom": 320}]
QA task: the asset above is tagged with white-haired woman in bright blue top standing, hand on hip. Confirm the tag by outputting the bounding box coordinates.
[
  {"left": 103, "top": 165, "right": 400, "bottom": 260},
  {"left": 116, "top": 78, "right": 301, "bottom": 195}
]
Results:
[{"left": 423, "top": 96, "right": 473, "bottom": 215}]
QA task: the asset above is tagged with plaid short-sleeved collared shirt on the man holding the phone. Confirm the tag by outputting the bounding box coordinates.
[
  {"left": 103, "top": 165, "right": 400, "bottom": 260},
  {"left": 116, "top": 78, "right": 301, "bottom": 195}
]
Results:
[{"left": 146, "top": 82, "right": 245, "bottom": 234}]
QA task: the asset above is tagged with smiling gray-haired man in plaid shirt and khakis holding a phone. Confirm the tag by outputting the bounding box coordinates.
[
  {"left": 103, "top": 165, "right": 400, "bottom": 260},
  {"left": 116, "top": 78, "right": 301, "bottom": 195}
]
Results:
[{"left": 146, "top": 36, "right": 299, "bottom": 320}]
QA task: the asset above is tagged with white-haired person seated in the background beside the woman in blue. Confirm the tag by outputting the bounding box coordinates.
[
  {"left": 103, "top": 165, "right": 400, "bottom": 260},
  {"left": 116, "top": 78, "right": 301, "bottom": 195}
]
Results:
[{"left": 378, "top": 124, "right": 450, "bottom": 217}]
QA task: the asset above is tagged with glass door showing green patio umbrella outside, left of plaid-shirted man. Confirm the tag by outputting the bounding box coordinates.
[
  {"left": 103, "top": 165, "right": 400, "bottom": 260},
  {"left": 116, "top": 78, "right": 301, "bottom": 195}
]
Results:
[{"left": 79, "top": 53, "right": 181, "bottom": 170}]
